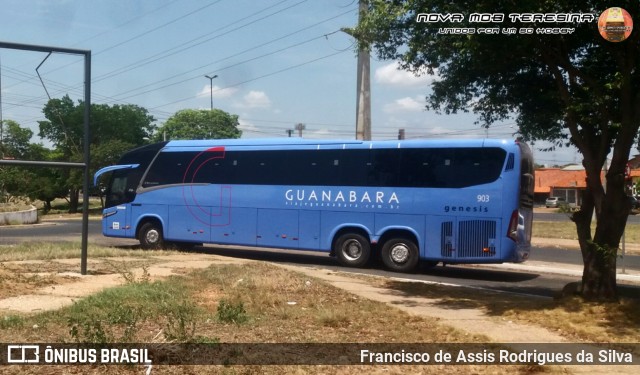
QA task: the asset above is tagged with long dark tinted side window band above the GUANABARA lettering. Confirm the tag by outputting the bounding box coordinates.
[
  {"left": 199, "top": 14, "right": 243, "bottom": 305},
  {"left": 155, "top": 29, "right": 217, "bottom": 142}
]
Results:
[{"left": 142, "top": 148, "right": 506, "bottom": 188}]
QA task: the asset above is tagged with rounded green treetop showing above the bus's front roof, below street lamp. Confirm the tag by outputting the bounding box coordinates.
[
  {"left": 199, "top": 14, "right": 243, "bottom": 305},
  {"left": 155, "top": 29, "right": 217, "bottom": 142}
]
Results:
[{"left": 155, "top": 109, "right": 242, "bottom": 141}]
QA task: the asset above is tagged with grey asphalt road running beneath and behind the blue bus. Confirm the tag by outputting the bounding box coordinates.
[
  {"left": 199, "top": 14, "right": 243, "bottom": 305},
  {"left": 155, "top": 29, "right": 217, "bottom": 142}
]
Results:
[{"left": 0, "top": 214, "right": 640, "bottom": 297}]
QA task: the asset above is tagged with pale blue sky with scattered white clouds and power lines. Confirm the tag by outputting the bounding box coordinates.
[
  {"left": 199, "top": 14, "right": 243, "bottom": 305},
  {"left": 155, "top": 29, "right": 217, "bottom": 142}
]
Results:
[{"left": 0, "top": 0, "right": 581, "bottom": 165}]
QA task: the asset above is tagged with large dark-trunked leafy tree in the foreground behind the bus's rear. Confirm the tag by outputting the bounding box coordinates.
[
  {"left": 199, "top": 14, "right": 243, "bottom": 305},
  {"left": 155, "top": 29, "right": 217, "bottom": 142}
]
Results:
[{"left": 353, "top": 0, "right": 640, "bottom": 300}]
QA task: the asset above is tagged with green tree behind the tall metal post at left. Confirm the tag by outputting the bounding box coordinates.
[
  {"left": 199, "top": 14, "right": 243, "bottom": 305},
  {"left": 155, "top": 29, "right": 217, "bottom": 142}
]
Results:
[{"left": 39, "top": 95, "right": 155, "bottom": 212}]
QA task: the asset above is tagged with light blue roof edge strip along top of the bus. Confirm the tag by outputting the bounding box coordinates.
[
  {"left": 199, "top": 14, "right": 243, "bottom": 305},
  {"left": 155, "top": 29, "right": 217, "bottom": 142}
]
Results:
[{"left": 164, "top": 138, "right": 517, "bottom": 151}]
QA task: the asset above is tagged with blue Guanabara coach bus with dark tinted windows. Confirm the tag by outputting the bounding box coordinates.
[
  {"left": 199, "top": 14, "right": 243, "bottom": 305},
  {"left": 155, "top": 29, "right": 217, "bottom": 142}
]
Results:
[{"left": 95, "top": 138, "right": 534, "bottom": 272}]
